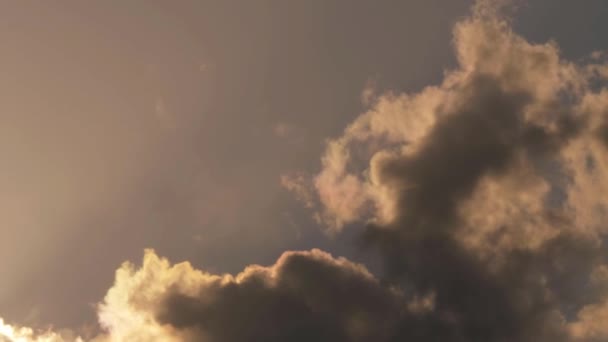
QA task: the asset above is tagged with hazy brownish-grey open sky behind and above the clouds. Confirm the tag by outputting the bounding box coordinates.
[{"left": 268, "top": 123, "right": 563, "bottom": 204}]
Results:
[{"left": 0, "top": 0, "right": 608, "bottom": 341}]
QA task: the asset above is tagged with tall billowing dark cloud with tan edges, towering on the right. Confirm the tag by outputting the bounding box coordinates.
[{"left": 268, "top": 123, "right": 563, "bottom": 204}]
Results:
[{"left": 306, "top": 1, "right": 608, "bottom": 341}]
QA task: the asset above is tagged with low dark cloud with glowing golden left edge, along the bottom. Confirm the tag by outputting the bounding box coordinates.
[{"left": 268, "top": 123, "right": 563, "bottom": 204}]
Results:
[{"left": 99, "top": 250, "right": 414, "bottom": 341}]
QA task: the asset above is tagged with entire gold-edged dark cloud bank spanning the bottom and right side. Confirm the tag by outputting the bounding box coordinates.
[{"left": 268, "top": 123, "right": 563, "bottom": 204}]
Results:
[{"left": 0, "top": 2, "right": 608, "bottom": 342}]
